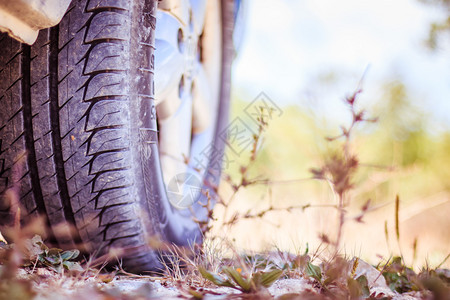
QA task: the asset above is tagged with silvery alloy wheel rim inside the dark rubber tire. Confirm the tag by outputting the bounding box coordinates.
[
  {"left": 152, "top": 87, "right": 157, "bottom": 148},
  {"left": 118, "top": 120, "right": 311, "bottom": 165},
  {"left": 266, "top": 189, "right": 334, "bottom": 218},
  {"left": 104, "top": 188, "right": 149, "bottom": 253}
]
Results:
[{"left": 155, "top": 0, "right": 222, "bottom": 209}]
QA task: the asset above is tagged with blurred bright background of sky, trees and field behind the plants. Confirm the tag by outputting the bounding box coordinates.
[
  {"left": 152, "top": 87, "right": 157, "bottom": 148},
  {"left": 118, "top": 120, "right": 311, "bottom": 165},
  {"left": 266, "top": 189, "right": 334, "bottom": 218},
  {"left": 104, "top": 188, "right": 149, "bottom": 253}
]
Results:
[{"left": 214, "top": 0, "right": 450, "bottom": 267}]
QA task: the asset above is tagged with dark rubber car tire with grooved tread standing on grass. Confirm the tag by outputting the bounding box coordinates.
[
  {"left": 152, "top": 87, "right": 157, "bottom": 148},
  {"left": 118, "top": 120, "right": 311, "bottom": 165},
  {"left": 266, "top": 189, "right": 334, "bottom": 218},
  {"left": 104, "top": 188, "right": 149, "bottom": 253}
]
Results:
[{"left": 0, "top": 0, "right": 233, "bottom": 272}]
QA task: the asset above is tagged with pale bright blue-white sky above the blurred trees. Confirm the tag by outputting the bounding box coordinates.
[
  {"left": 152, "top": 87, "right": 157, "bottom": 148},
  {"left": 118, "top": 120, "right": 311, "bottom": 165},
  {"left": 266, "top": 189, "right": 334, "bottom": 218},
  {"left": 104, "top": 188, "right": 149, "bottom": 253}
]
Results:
[{"left": 233, "top": 0, "right": 450, "bottom": 130}]
